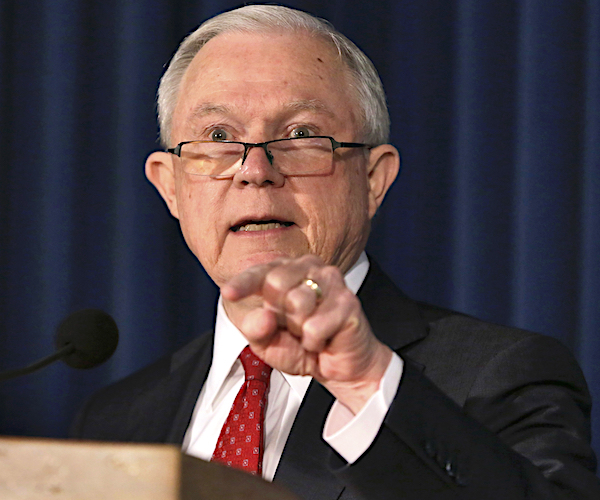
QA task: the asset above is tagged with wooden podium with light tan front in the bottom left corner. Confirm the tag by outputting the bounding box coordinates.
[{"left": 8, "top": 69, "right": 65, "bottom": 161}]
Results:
[{"left": 0, "top": 437, "right": 299, "bottom": 500}]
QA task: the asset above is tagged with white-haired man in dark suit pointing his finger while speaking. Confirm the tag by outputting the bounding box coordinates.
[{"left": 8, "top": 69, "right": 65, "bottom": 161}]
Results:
[{"left": 74, "top": 6, "right": 600, "bottom": 500}]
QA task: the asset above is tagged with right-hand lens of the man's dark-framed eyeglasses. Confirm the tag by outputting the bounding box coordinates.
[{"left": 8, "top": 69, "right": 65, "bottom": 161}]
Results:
[{"left": 268, "top": 137, "right": 333, "bottom": 175}]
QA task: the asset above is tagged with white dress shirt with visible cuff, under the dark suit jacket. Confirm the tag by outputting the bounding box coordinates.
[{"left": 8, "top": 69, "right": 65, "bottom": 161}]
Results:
[{"left": 183, "top": 252, "right": 403, "bottom": 481}]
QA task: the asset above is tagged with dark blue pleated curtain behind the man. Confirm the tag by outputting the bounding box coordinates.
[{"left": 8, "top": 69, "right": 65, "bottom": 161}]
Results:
[{"left": 0, "top": 0, "right": 600, "bottom": 464}]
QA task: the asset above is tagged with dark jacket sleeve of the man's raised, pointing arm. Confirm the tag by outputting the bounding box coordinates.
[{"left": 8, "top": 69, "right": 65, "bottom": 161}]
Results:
[{"left": 332, "top": 335, "right": 600, "bottom": 500}]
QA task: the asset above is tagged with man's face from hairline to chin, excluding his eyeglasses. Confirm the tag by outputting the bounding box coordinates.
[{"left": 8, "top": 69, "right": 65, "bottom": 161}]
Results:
[{"left": 147, "top": 33, "right": 398, "bottom": 286}]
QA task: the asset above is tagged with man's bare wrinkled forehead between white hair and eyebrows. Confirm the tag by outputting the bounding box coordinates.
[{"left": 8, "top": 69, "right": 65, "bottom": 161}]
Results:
[{"left": 173, "top": 32, "right": 356, "bottom": 138}]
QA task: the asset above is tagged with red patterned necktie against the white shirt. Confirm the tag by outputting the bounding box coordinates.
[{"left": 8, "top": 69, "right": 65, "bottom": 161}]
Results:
[{"left": 212, "top": 346, "right": 272, "bottom": 476}]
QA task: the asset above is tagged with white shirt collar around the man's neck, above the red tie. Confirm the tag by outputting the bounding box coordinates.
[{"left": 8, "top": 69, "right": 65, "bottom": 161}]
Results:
[{"left": 207, "top": 252, "right": 369, "bottom": 398}]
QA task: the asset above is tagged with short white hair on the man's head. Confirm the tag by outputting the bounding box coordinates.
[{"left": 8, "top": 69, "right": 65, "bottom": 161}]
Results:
[{"left": 158, "top": 5, "right": 390, "bottom": 147}]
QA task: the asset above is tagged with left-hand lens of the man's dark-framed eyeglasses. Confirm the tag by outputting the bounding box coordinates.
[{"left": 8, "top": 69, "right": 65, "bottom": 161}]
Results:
[{"left": 180, "top": 141, "right": 244, "bottom": 176}]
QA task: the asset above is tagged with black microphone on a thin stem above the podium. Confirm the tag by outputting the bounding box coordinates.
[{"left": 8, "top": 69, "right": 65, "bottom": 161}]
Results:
[{"left": 0, "top": 309, "right": 119, "bottom": 381}]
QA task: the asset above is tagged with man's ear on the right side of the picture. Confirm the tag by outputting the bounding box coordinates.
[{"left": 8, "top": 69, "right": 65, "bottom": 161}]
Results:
[{"left": 367, "top": 144, "right": 400, "bottom": 218}]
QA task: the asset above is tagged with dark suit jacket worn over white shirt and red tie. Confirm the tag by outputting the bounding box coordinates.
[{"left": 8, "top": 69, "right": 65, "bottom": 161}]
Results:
[{"left": 73, "top": 263, "right": 600, "bottom": 500}]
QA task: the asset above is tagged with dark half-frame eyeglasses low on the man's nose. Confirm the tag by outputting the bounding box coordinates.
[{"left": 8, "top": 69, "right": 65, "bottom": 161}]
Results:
[{"left": 167, "top": 135, "right": 373, "bottom": 178}]
